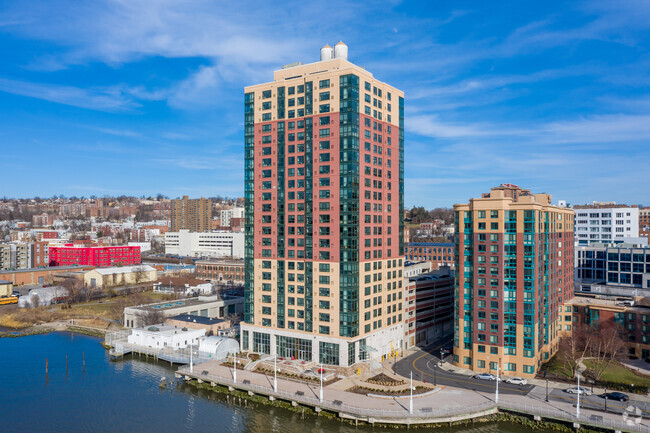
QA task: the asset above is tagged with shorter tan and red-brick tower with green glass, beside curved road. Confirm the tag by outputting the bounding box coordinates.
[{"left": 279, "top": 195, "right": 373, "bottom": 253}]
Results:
[{"left": 453, "top": 184, "right": 574, "bottom": 377}]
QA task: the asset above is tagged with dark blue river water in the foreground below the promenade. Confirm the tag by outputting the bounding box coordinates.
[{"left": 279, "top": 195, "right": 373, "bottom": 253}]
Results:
[{"left": 0, "top": 332, "right": 543, "bottom": 433}]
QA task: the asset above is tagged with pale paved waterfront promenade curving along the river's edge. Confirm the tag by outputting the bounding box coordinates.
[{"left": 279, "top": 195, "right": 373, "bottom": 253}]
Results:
[{"left": 177, "top": 361, "right": 650, "bottom": 433}]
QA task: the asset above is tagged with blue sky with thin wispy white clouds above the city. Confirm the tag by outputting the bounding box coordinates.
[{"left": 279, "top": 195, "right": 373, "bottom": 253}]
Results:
[{"left": 0, "top": 0, "right": 650, "bottom": 207}]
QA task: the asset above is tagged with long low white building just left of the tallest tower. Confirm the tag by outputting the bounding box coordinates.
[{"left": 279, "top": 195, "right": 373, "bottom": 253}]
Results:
[{"left": 165, "top": 230, "right": 244, "bottom": 259}]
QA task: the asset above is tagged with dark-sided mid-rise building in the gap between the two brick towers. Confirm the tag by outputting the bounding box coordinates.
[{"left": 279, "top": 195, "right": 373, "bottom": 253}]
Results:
[{"left": 404, "top": 267, "right": 454, "bottom": 348}]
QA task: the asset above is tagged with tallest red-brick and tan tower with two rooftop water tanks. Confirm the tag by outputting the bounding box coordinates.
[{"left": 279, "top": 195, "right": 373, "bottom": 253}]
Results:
[{"left": 242, "top": 42, "right": 404, "bottom": 366}]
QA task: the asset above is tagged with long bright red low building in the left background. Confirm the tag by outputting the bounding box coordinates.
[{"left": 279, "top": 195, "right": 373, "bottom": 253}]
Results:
[{"left": 50, "top": 245, "right": 140, "bottom": 267}]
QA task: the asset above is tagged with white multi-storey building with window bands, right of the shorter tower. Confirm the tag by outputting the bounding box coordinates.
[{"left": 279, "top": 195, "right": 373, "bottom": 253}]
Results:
[{"left": 573, "top": 202, "right": 639, "bottom": 246}]
